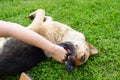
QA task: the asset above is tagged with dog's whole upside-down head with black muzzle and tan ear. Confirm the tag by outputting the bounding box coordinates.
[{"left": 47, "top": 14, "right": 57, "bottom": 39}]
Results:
[{"left": 59, "top": 42, "right": 97, "bottom": 72}]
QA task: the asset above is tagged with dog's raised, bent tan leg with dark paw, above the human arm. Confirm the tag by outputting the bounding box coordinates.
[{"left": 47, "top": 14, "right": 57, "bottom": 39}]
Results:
[{"left": 27, "top": 9, "right": 45, "bottom": 34}]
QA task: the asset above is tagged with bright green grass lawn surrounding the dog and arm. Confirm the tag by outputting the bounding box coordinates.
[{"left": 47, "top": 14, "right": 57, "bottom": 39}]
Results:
[{"left": 0, "top": 0, "right": 120, "bottom": 80}]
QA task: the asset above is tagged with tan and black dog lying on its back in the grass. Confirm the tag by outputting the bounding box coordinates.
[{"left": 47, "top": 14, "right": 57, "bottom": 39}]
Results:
[{"left": 0, "top": 10, "right": 97, "bottom": 76}]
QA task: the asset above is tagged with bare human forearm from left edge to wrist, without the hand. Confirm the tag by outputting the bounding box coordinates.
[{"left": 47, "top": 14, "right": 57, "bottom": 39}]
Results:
[{"left": 0, "top": 22, "right": 56, "bottom": 53}]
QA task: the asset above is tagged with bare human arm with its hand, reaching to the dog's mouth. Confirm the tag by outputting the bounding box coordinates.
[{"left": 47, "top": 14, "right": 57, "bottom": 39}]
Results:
[{"left": 0, "top": 21, "right": 67, "bottom": 62}]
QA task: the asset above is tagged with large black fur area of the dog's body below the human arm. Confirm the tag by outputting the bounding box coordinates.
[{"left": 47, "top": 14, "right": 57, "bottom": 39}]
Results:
[{"left": 0, "top": 38, "right": 46, "bottom": 76}]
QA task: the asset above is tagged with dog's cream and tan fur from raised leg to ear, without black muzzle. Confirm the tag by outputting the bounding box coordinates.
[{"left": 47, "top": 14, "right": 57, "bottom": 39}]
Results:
[{"left": 28, "top": 9, "right": 98, "bottom": 65}]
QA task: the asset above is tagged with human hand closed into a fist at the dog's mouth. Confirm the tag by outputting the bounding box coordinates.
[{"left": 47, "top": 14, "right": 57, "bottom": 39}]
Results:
[{"left": 51, "top": 45, "right": 67, "bottom": 63}]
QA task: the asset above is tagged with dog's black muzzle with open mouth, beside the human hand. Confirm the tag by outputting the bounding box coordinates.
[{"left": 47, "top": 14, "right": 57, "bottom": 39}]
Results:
[{"left": 59, "top": 42, "right": 76, "bottom": 72}]
